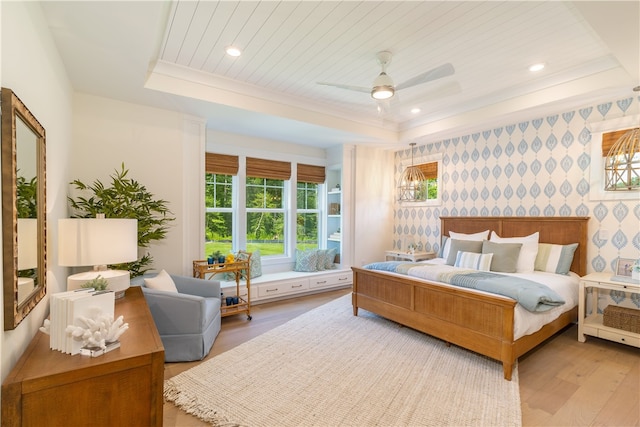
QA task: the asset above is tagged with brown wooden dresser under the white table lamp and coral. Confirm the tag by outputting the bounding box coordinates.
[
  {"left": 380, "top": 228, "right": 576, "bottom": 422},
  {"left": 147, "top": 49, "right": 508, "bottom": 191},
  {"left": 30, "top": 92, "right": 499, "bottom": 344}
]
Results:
[{"left": 2, "top": 286, "right": 164, "bottom": 426}]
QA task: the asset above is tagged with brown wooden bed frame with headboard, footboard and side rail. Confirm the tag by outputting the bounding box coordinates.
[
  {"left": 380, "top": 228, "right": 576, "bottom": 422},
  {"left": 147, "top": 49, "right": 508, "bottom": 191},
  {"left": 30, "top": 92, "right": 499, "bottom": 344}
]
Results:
[{"left": 352, "top": 217, "right": 589, "bottom": 380}]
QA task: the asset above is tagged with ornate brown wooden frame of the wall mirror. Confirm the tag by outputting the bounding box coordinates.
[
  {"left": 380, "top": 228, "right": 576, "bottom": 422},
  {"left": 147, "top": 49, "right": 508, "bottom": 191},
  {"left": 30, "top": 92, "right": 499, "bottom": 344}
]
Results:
[{"left": 0, "top": 88, "right": 47, "bottom": 331}]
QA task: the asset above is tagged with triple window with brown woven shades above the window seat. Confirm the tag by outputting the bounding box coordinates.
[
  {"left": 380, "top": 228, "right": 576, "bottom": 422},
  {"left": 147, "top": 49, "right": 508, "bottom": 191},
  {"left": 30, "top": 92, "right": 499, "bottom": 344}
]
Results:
[{"left": 205, "top": 153, "right": 325, "bottom": 262}]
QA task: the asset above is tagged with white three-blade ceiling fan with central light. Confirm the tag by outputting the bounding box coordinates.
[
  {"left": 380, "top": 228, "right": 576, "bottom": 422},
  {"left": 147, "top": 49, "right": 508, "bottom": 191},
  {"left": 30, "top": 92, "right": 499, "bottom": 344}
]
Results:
[{"left": 318, "top": 51, "right": 455, "bottom": 101}]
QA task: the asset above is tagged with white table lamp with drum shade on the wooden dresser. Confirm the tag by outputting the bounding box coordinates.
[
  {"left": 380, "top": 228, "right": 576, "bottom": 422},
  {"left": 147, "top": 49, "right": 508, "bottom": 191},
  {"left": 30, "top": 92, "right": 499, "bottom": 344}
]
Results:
[{"left": 58, "top": 217, "right": 138, "bottom": 298}]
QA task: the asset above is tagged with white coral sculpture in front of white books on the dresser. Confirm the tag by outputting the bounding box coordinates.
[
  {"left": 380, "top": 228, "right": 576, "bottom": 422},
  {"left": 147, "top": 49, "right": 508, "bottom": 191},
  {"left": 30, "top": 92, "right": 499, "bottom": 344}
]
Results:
[{"left": 66, "top": 313, "right": 129, "bottom": 349}]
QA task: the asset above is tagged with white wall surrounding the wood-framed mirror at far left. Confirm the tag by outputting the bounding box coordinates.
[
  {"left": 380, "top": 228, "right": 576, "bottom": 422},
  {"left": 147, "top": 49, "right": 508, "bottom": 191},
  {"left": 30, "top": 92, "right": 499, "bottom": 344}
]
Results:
[{"left": 0, "top": 2, "right": 72, "bottom": 386}]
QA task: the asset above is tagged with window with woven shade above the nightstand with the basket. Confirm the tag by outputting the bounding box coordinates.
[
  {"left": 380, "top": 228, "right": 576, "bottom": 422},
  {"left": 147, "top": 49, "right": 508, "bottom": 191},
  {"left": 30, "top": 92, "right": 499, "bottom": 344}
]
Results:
[{"left": 602, "top": 128, "right": 640, "bottom": 191}]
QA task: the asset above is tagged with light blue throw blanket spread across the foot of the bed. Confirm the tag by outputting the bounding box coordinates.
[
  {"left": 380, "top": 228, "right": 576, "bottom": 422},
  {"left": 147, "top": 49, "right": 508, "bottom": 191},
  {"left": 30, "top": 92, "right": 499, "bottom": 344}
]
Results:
[{"left": 363, "top": 261, "right": 565, "bottom": 312}]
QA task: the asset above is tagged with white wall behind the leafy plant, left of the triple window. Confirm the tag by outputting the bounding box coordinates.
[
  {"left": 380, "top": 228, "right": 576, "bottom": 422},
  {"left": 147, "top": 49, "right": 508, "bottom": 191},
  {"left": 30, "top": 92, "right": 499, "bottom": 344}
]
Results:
[{"left": 68, "top": 94, "right": 205, "bottom": 275}]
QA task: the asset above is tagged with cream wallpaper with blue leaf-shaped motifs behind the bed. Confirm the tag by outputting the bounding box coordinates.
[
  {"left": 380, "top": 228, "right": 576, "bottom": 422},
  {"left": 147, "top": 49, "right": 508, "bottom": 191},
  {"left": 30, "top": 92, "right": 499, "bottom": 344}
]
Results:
[{"left": 393, "top": 97, "right": 640, "bottom": 280}]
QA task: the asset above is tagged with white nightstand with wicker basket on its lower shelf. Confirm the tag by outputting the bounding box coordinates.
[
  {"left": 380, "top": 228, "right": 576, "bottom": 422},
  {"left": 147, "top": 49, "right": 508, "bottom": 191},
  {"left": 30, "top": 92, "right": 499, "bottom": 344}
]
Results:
[{"left": 578, "top": 273, "right": 640, "bottom": 347}]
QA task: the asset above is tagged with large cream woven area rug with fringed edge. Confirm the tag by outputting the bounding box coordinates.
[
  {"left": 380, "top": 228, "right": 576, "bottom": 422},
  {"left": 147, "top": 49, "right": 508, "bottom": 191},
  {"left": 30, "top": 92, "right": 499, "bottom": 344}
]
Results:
[{"left": 164, "top": 295, "right": 521, "bottom": 427}]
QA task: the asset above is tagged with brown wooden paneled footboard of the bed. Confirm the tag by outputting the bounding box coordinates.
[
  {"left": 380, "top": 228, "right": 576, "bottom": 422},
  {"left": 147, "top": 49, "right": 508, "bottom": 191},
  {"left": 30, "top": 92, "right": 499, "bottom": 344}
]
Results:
[{"left": 352, "top": 267, "right": 518, "bottom": 380}]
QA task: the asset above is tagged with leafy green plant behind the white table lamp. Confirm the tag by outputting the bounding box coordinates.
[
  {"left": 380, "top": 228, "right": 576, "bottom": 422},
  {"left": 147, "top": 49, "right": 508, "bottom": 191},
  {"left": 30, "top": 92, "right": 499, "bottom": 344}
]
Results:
[{"left": 67, "top": 163, "right": 175, "bottom": 277}]
